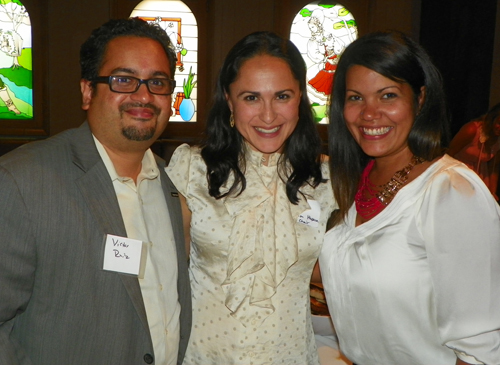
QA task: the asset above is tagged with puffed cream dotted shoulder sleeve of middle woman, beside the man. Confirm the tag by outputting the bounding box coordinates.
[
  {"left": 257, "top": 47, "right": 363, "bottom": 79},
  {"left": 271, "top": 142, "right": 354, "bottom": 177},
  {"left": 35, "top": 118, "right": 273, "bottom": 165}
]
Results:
[{"left": 165, "top": 143, "right": 206, "bottom": 196}]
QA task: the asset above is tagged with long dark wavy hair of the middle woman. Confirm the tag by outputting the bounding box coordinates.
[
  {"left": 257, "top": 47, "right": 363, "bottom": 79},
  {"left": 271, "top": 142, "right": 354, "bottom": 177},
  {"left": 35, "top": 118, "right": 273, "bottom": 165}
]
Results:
[{"left": 201, "top": 32, "right": 324, "bottom": 204}]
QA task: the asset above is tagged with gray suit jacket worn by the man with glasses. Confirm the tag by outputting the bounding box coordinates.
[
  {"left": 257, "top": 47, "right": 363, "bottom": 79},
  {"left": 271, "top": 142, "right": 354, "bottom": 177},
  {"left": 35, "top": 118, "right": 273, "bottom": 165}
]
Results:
[{"left": 0, "top": 123, "right": 191, "bottom": 365}]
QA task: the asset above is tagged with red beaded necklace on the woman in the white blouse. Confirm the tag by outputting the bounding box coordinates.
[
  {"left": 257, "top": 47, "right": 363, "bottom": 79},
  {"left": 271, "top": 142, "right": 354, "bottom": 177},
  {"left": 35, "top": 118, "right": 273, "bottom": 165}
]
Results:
[{"left": 354, "top": 156, "right": 425, "bottom": 220}]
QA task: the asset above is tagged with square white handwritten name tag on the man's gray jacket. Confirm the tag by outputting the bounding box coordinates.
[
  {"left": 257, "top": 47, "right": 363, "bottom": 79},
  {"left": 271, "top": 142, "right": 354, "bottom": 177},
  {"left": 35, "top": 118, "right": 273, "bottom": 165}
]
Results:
[{"left": 103, "top": 234, "right": 147, "bottom": 278}]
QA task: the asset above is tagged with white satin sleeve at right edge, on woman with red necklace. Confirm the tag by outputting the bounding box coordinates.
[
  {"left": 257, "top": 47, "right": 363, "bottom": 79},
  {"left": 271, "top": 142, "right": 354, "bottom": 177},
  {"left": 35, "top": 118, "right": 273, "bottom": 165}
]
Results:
[{"left": 417, "top": 166, "right": 500, "bottom": 364}]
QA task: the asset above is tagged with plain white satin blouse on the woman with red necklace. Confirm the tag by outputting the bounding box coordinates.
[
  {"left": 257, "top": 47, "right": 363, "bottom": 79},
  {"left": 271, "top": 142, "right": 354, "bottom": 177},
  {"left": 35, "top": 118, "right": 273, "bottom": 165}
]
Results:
[{"left": 320, "top": 155, "right": 500, "bottom": 365}]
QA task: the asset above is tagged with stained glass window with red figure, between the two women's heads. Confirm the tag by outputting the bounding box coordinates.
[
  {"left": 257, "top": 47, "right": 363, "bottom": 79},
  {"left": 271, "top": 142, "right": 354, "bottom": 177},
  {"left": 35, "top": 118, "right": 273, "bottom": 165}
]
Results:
[{"left": 290, "top": 1, "right": 358, "bottom": 123}]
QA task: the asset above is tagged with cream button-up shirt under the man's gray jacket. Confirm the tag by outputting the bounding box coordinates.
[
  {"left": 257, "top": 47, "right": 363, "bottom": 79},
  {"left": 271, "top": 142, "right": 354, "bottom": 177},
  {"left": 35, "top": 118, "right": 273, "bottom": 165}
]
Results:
[{"left": 94, "top": 137, "right": 181, "bottom": 365}]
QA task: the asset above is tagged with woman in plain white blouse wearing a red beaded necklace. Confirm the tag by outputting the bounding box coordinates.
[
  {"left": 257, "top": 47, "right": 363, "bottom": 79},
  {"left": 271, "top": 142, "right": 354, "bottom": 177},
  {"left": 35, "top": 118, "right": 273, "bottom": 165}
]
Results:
[{"left": 319, "top": 32, "right": 500, "bottom": 365}]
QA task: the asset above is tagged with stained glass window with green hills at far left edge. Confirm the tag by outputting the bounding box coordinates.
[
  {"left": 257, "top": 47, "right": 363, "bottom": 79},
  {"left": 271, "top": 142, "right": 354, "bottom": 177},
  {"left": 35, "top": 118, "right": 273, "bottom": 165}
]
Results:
[{"left": 0, "top": 0, "right": 33, "bottom": 119}]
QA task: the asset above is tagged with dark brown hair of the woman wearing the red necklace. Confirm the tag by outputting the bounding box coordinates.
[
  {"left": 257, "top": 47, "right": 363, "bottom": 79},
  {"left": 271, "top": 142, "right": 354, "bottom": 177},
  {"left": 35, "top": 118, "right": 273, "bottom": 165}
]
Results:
[{"left": 328, "top": 32, "right": 449, "bottom": 225}]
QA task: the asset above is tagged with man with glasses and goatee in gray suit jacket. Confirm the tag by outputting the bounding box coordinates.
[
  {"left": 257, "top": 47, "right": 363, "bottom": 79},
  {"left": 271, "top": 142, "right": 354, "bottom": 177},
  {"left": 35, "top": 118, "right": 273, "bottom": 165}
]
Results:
[{"left": 0, "top": 19, "right": 191, "bottom": 365}]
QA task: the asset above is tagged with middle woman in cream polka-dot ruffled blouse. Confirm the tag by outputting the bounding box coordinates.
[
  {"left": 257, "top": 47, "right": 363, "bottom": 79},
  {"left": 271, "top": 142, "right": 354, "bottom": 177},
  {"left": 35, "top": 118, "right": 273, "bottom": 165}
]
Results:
[{"left": 167, "top": 32, "right": 335, "bottom": 365}]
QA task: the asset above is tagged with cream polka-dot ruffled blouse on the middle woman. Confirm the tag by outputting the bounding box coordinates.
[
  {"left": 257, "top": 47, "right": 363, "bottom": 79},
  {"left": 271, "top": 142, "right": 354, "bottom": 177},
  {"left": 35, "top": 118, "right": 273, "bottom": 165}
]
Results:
[{"left": 167, "top": 145, "right": 336, "bottom": 365}]
